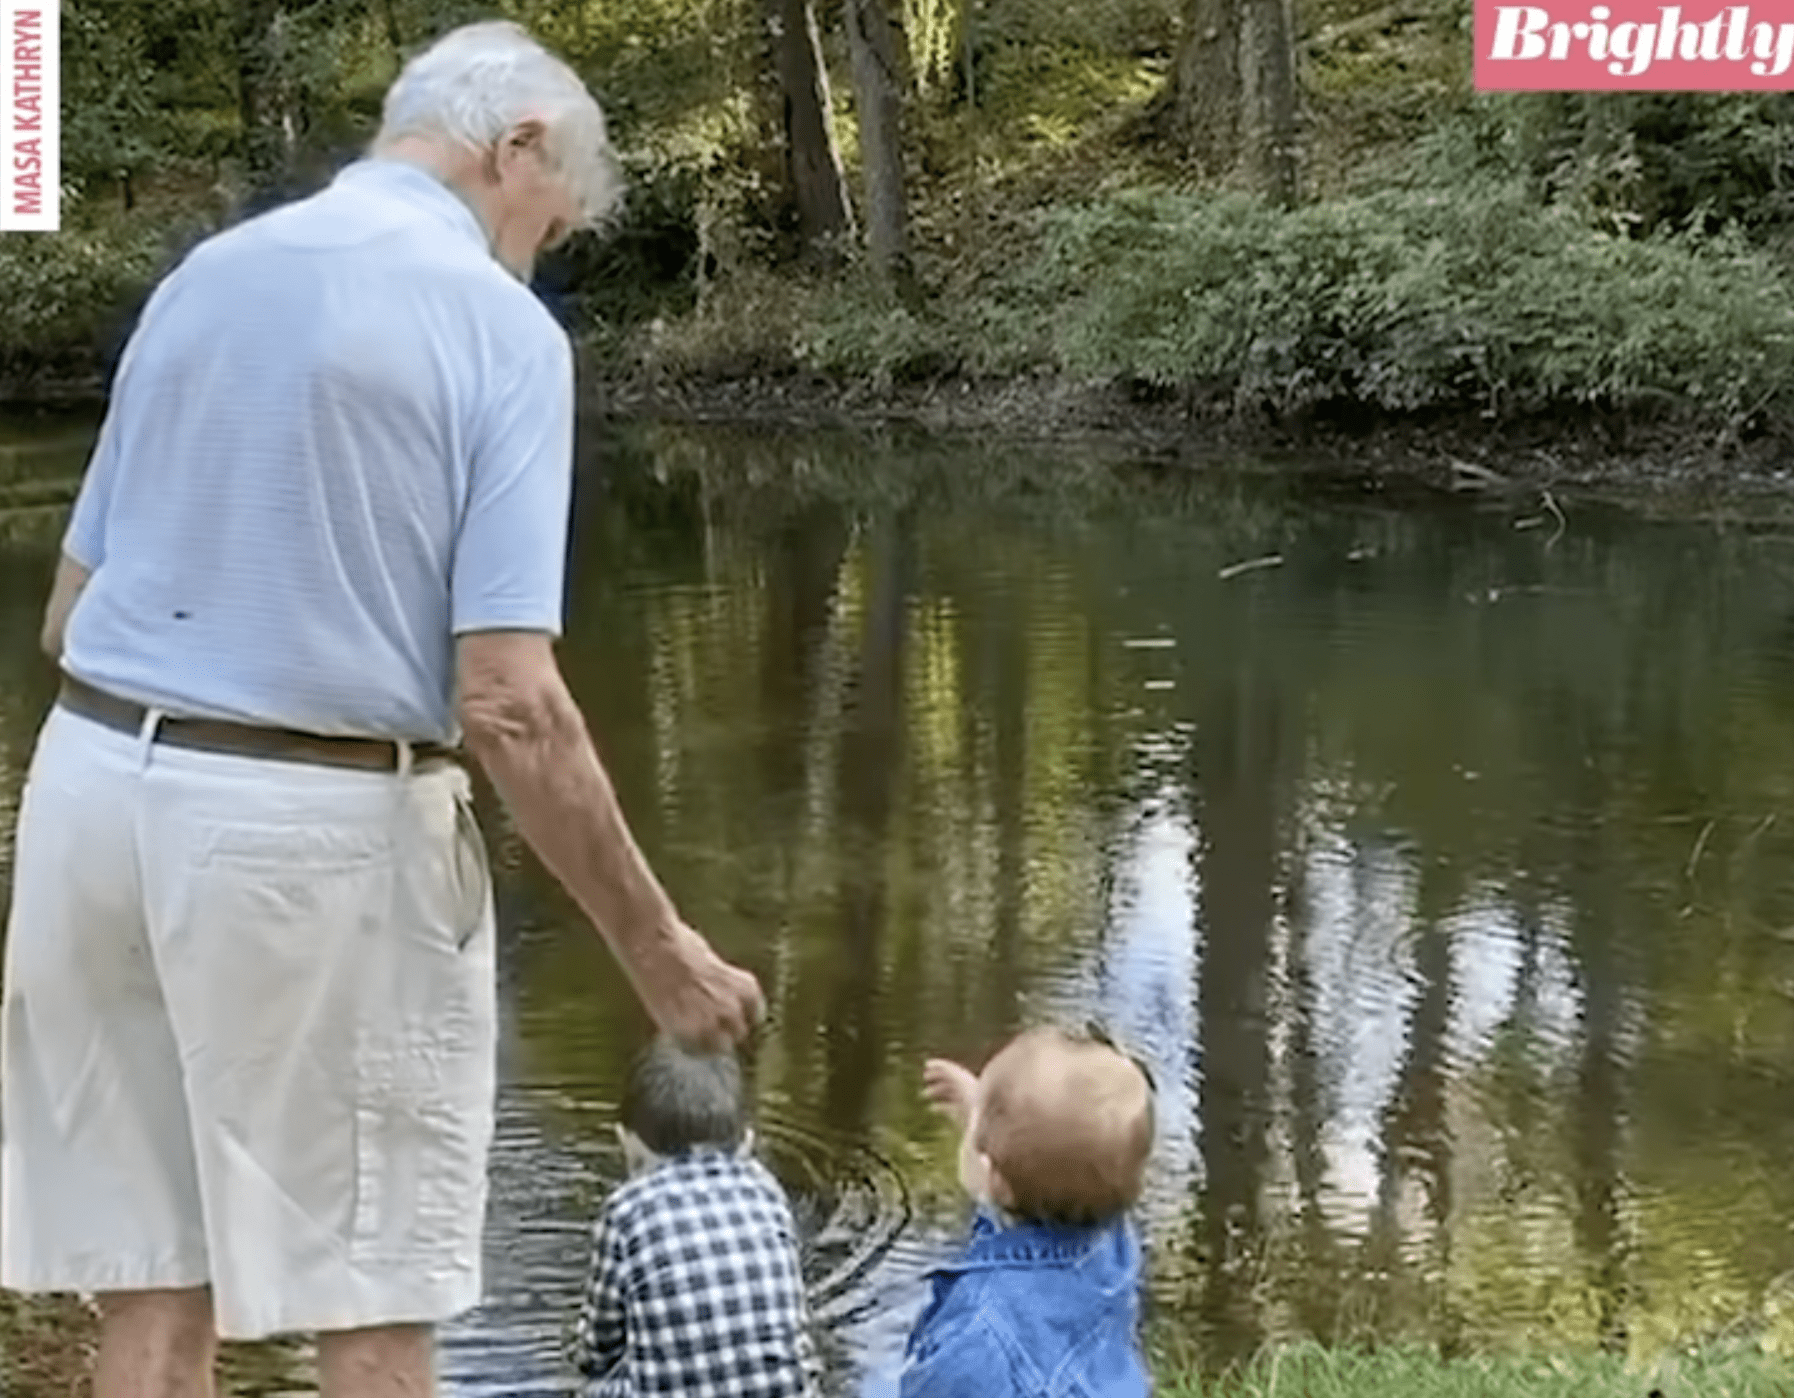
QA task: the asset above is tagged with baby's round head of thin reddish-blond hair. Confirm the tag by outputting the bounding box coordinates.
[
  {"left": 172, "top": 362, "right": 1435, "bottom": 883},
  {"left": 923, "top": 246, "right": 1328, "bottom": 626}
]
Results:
[{"left": 972, "top": 1028, "right": 1154, "bottom": 1224}]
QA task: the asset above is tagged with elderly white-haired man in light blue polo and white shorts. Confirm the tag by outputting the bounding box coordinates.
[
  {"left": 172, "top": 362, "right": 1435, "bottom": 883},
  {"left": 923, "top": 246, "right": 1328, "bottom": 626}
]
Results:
[{"left": 0, "top": 23, "right": 762, "bottom": 1398}]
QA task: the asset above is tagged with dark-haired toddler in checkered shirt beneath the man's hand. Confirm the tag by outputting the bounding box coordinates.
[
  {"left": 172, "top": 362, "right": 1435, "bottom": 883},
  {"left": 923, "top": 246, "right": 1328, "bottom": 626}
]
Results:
[{"left": 574, "top": 1039, "right": 820, "bottom": 1398}]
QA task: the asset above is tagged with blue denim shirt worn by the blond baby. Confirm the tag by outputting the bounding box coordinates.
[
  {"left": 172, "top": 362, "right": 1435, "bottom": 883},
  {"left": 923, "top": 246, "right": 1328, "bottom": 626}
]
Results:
[{"left": 899, "top": 1211, "right": 1152, "bottom": 1398}]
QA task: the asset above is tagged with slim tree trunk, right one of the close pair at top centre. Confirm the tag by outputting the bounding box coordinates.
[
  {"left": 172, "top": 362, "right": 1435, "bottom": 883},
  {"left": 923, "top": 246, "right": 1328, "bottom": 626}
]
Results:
[{"left": 845, "top": 0, "right": 915, "bottom": 300}]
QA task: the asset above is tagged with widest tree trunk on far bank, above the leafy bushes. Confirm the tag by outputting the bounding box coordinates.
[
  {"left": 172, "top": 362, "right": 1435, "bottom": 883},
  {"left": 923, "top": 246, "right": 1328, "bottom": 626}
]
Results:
[{"left": 1171, "top": 0, "right": 1301, "bottom": 206}]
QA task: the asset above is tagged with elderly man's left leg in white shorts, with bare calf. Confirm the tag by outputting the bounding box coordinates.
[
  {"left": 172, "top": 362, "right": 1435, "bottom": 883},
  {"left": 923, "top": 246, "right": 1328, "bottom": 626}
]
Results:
[{"left": 0, "top": 721, "right": 215, "bottom": 1398}]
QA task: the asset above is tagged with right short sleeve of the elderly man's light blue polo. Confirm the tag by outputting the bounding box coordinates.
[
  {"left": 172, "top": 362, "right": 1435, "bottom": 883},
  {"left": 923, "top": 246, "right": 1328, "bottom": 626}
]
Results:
[{"left": 449, "top": 328, "right": 574, "bottom": 635}]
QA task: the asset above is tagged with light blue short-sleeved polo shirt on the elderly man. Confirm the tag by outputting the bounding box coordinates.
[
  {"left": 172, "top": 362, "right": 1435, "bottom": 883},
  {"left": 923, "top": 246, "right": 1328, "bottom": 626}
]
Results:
[{"left": 63, "top": 160, "right": 574, "bottom": 741}]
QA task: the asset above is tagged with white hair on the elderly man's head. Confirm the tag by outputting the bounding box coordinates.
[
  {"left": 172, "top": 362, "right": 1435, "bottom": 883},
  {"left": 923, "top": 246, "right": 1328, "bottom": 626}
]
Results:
[{"left": 375, "top": 20, "right": 623, "bottom": 224}]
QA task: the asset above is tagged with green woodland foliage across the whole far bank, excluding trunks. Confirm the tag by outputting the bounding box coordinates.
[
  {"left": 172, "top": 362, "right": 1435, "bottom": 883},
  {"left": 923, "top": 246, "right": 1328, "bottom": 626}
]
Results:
[{"left": 21, "top": 0, "right": 1794, "bottom": 448}]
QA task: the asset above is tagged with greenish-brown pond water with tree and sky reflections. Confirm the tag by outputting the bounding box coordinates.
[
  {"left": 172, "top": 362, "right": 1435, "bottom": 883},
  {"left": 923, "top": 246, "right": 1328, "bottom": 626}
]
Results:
[{"left": 0, "top": 412, "right": 1794, "bottom": 1398}]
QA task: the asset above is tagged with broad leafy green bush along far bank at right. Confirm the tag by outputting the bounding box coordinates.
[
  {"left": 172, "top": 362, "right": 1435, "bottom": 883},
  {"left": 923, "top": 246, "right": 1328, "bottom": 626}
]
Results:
[{"left": 1005, "top": 183, "right": 1794, "bottom": 424}]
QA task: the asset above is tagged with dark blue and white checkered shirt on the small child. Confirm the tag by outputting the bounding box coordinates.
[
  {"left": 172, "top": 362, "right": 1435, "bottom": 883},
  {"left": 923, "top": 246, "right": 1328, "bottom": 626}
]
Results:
[{"left": 574, "top": 1149, "right": 822, "bottom": 1398}]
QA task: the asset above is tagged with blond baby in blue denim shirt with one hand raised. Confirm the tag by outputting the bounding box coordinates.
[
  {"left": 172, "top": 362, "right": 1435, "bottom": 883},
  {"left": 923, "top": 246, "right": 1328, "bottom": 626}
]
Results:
[{"left": 899, "top": 1028, "right": 1154, "bottom": 1398}]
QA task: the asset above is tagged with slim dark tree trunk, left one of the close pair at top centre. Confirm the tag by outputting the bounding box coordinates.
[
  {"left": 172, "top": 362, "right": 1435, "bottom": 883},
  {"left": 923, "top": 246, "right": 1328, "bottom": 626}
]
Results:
[{"left": 764, "top": 0, "right": 852, "bottom": 255}]
